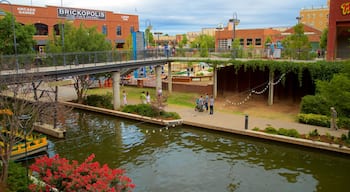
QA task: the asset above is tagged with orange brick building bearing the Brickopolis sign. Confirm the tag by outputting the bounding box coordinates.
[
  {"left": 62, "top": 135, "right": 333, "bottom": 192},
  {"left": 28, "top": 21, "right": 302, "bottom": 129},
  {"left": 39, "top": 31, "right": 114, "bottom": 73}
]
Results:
[{"left": 0, "top": 4, "right": 139, "bottom": 51}]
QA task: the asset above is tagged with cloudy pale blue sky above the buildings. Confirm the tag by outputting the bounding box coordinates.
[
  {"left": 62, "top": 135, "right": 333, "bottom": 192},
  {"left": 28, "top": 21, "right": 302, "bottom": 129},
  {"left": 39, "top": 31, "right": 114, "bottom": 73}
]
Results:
[{"left": 8, "top": 0, "right": 327, "bottom": 35}]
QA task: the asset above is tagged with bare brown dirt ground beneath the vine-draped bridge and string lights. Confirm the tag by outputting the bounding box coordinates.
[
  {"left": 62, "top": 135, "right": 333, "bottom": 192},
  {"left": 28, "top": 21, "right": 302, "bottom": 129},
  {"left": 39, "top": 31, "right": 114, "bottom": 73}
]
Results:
[{"left": 215, "top": 95, "right": 300, "bottom": 122}]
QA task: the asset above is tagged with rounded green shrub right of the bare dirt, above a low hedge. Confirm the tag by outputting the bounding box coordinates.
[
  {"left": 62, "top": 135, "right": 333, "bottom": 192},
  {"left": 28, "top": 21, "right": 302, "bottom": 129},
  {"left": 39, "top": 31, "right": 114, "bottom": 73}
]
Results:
[{"left": 300, "top": 95, "right": 330, "bottom": 115}]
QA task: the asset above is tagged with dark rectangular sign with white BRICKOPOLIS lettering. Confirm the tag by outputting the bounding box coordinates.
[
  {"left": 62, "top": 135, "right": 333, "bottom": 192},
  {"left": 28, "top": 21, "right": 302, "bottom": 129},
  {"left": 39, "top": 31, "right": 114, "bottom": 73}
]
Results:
[{"left": 57, "top": 8, "right": 106, "bottom": 20}]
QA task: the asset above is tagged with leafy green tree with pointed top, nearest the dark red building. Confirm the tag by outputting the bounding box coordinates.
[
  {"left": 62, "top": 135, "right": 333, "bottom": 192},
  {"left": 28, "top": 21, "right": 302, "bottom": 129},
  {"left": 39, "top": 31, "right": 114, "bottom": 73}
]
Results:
[{"left": 282, "top": 23, "right": 311, "bottom": 59}]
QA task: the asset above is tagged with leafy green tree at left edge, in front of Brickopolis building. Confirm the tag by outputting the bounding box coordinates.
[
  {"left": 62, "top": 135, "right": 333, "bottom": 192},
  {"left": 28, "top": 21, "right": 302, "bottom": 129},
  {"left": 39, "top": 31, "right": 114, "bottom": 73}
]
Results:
[{"left": 0, "top": 13, "right": 35, "bottom": 55}]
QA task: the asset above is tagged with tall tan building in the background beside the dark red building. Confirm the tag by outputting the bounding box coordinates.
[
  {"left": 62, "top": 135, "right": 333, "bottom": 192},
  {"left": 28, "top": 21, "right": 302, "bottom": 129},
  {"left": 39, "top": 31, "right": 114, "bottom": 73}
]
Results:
[{"left": 299, "top": 0, "right": 330, "bottom": 31}]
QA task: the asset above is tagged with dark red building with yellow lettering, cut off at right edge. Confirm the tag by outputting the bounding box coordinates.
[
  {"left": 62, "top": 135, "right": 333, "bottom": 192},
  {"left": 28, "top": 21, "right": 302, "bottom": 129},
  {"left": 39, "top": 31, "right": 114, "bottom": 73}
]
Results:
[{"left": 327, "top": 0, "right": 350, "bottom": 60}]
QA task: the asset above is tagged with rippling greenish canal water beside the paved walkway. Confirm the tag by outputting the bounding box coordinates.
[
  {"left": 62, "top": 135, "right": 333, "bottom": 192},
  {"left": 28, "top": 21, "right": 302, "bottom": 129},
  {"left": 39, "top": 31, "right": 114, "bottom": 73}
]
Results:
[{"left": 49, "top": 111, "right": 350, "bottom": 192}]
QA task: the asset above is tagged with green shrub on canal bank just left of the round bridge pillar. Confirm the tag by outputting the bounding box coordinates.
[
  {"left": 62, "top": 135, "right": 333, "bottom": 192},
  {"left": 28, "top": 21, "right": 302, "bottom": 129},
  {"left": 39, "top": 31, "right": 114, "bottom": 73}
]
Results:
[{"left": 84, "top": 93, "right": 113, "bottom": 109}]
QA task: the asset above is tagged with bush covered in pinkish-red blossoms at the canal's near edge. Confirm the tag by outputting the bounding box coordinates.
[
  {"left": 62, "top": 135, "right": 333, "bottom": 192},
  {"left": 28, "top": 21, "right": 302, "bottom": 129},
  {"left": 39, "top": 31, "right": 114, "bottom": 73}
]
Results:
[{"left": 29, "top": 154, "right": 135, "bottom": 192}]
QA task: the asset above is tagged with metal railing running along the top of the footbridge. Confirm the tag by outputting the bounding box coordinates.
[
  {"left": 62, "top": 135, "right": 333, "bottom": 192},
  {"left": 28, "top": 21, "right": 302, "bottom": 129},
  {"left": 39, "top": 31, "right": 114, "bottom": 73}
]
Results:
[{"left": 0, "top": 48, "right": 350, "bottom": 70}]
